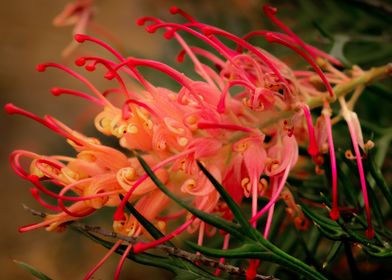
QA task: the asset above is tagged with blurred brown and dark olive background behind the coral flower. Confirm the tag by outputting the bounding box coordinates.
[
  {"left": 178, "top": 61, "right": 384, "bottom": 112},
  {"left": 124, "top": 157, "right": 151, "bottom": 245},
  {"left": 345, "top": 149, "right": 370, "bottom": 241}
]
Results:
[{"left": 0, "top": 0, "right": 392, "bottom": 279}]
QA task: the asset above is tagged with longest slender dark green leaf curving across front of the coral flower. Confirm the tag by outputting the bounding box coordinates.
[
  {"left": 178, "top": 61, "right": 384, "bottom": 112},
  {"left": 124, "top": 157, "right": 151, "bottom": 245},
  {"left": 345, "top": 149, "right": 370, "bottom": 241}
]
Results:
[{"left": 136, "top": 155, "right": 243, "bottom": 239}]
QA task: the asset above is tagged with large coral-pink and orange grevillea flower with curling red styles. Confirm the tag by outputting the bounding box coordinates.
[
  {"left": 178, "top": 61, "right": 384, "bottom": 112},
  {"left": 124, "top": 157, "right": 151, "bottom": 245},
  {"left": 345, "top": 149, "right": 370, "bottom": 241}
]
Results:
[{"left": 5, "top": 4, "right": 373, "bottom": 279}]
